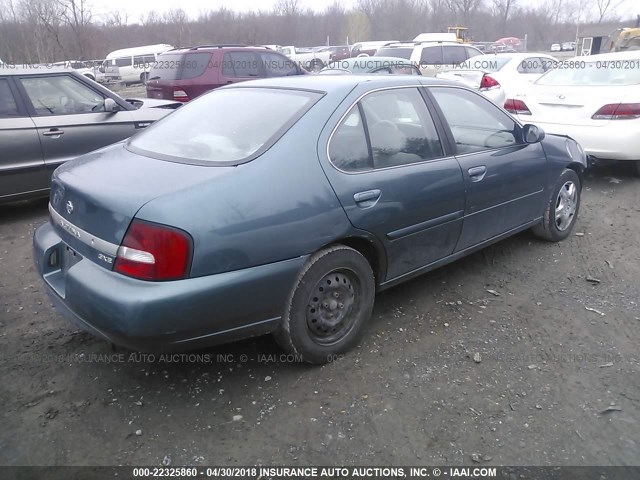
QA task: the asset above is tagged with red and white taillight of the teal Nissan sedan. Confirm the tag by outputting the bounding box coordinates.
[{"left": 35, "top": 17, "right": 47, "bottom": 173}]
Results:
[{"left": 114, "top": 220, "right": 191, "bottom": 281}]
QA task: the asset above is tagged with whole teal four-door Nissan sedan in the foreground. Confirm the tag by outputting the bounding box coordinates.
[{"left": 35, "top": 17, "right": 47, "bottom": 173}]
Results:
[{"left": 34, "top": 76, "right": 586, "bottom": 363}]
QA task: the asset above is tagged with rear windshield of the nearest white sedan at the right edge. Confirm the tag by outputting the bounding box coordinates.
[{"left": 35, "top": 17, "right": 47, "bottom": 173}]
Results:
[{"left": 535, "top": 59, "right": 640, "bottom": 85}]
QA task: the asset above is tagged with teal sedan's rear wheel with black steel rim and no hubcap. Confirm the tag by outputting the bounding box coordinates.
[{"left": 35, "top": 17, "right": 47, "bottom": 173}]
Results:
[{"left": 274, "top": 245, "right": 375, "bottom": 364}]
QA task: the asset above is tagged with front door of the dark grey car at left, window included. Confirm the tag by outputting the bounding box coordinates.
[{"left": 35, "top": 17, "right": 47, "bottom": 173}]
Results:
[{"left": 19, "top": 74, "right": 137, "bottom": 177}]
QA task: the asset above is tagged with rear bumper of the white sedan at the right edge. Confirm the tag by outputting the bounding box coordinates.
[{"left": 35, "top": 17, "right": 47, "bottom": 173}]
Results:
[{"left": 519, "top": 121, "right": 640, "bottom": 160}]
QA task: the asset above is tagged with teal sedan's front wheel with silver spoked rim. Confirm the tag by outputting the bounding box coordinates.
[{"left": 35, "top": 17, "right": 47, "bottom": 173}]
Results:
[{"left": 532, "top": 169, "right": 582, "bottom": 242}]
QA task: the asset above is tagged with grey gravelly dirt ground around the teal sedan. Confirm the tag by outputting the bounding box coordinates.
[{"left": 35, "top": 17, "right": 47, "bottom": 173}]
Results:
[{"left": 0, "top": 162, "right": 640, "bottom": 466}]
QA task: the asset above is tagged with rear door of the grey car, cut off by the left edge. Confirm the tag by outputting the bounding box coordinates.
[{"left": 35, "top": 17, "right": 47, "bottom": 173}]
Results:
[{"left": 0, "top": 77, "right": 48, "bottom": 200}]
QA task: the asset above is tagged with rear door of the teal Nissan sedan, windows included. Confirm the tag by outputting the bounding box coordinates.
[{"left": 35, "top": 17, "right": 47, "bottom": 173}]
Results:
[{"left": 320, "top": 87, "right": 464, "bottom": 280}]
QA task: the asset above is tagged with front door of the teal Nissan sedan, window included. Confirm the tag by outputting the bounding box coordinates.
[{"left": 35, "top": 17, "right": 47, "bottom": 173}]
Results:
[{"left": 429, "top": 87, "right": 547, "bottom": 252}]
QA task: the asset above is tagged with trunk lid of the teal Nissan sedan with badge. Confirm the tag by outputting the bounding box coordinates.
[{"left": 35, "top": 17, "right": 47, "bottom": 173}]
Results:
[{"left": 50, "top": 143, "right": 234, "bottom": 257}]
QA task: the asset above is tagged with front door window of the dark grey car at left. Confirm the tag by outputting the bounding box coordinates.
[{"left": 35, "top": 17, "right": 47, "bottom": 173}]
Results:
[{"left": 20, "top": 75, "right": 105, "bottom": 115}]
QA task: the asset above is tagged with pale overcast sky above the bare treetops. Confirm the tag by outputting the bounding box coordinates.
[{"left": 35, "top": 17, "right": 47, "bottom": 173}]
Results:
[{"left": 91, "top": 0, "right": 640, "bottom": 23}]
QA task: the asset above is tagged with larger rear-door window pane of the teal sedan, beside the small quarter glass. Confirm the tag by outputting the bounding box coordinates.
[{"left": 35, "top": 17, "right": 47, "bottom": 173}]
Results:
[{"left": 362, "top": 88, "right": 443, "bottom": 168}]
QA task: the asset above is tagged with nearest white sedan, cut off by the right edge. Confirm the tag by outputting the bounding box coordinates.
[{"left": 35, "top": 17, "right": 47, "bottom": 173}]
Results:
[{"left": 504, "top": 50, "right": 640, "bottom": 176}]
